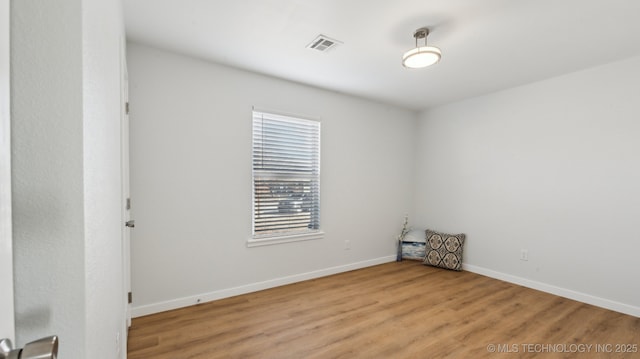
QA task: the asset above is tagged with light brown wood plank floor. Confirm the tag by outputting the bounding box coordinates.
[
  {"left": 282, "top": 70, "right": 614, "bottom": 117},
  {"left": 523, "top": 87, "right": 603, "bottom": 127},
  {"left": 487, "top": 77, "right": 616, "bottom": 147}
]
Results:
[{"left": 128, "top": 261, "right": 640, "bottom": 359}]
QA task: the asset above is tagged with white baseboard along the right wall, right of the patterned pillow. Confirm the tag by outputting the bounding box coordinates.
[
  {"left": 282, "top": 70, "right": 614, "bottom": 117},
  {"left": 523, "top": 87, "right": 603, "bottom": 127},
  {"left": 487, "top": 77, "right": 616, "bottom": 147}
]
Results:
[{"left": 462, "top": 264, "right": 640, "bottom": 317}]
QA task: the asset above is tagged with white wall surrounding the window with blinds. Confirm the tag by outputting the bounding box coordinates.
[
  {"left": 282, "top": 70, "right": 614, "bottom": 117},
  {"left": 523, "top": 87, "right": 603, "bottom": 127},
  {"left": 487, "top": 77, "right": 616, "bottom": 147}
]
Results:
[{"left": 127, "top": 43, "right": 416, "bottom": 315}]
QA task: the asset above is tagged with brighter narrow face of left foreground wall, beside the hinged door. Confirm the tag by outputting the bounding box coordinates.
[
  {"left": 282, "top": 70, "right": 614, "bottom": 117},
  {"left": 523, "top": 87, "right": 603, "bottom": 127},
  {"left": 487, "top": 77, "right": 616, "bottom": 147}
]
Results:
[{"left": 82, "top": 0, "right": 127, "bottom": 358}]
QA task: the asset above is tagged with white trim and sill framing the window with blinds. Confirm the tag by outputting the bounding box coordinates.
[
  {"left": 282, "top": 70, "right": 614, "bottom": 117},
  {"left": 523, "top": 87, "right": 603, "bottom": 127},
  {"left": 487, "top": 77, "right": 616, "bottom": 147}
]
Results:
[{"left": 247, "top": 106, "right": 324, "bottom": 248}]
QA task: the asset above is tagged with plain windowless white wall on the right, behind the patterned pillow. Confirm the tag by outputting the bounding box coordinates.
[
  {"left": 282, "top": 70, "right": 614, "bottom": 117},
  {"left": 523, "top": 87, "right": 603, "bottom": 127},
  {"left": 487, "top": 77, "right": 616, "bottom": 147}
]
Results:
[{"left": 415, "top": 57, "right": 640, "bottom": 316}]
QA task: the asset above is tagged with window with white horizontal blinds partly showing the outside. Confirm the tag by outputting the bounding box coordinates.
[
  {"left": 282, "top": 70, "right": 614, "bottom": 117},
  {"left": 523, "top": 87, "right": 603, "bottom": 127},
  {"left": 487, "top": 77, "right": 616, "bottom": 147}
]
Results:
[{"left": 250, "top": 111, "right": 320, "bottom": 245}]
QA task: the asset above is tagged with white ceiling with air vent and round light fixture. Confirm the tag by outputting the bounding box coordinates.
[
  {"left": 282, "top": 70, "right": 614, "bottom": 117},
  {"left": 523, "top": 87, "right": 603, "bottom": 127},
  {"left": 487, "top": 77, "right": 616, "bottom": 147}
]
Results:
[{"left": 124, "top": 0, "right": 640, "bottom": 110}]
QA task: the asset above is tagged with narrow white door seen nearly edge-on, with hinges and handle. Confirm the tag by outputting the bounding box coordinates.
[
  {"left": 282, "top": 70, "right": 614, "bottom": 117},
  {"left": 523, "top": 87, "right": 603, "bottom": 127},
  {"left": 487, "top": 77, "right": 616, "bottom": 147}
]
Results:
[{"left": 120, "top": 38, "right": 133, "bottom": 332}]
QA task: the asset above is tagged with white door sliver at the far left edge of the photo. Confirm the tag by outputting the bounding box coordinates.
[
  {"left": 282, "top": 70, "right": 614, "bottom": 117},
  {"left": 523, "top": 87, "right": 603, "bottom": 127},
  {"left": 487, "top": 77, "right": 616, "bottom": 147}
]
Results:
[{"left": 0, "top": 0, "right": 15, "bottom": 342}]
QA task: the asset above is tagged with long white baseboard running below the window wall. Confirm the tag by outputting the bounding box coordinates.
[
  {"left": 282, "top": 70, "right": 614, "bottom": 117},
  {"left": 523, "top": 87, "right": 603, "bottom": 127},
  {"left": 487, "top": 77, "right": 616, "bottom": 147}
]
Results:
[{"left": 131, "top": 255, "right": 396, "bottom": 318}]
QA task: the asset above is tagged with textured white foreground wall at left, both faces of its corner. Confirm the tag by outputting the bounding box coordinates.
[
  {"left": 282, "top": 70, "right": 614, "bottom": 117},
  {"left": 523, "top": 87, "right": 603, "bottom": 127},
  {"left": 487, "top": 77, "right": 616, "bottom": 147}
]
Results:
[{"left": 11, "top": 0, "right": 125, "bottom": 359}]
